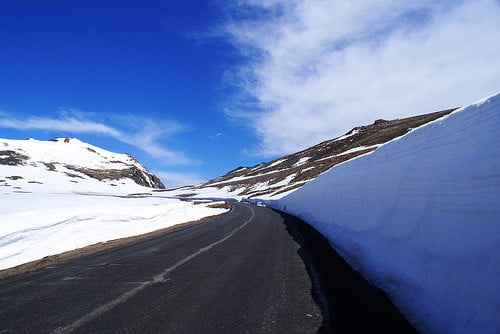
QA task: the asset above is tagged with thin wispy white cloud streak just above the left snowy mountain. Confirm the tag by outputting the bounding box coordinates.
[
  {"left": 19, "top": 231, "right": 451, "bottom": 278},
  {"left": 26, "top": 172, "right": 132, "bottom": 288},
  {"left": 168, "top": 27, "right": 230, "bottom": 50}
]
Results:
[{"left": 0, "top": 109, "right": 196, "bottom": 165}]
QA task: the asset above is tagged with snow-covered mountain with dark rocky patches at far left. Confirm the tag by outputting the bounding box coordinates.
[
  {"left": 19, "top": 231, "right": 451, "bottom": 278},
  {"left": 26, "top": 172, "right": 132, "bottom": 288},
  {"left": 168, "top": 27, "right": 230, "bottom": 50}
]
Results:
[{"left": 0, "top": 137, "right": 165, "bottom": 193}]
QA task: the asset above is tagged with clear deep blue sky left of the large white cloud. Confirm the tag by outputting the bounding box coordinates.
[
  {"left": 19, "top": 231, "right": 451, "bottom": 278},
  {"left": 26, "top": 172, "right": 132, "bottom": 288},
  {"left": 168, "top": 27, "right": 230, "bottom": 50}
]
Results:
[{"left": 0, "top": 0, "right": 254, "bottom": 182}]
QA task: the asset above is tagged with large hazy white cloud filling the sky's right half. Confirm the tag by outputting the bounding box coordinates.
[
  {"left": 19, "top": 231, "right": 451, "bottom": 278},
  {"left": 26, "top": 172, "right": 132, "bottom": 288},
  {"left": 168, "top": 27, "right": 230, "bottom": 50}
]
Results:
[{"left": 222, "top": 0, "right": 500, "bottom": 155}]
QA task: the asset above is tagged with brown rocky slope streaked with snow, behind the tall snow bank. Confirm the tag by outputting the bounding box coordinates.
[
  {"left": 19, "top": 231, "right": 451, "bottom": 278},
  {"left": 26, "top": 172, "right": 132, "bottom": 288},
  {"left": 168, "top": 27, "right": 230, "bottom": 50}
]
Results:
[{"left": 166, "top": 108, "right": 456, "bottom": 198}]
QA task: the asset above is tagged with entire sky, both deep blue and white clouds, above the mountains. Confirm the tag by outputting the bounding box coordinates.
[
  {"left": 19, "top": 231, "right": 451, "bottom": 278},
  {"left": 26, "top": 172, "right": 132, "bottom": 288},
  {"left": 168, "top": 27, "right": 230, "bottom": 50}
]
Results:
[{"left": 0, "top": 0, "right": 500, "bottom": 186}]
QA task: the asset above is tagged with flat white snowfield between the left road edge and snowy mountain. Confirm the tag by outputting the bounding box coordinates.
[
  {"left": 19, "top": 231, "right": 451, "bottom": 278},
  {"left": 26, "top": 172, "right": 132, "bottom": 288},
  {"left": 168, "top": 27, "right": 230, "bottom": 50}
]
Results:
[{"left": 0, "top": 193, "right": 227, "bottom": 270}]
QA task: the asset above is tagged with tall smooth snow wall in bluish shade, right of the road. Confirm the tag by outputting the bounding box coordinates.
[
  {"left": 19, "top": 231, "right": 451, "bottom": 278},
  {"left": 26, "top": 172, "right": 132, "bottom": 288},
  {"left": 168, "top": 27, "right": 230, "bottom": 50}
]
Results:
[{"left": 272, "top": 94, "right": 500, "bottom": 333}]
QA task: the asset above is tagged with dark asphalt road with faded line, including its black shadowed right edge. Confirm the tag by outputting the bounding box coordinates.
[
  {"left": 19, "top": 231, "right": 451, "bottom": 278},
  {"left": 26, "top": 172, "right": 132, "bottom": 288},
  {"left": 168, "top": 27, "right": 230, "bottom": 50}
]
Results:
[{"left": 0, "top": 204, "right": 413, "bottom": 333}]
